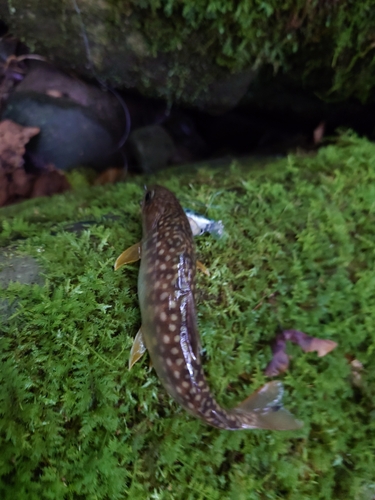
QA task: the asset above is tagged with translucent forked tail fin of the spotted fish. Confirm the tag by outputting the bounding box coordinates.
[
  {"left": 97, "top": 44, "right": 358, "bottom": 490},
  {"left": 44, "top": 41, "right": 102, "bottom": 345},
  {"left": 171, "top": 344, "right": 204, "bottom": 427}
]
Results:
[{"left": 232, "top": 381, "right": 303, "bottom": 431}]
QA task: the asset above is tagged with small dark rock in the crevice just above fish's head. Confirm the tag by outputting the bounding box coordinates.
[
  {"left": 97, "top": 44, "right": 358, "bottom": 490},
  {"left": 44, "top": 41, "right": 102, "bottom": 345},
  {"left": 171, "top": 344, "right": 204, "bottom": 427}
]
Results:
[{"left": 128, "top": 125, "right": 175, "bottom": 174}]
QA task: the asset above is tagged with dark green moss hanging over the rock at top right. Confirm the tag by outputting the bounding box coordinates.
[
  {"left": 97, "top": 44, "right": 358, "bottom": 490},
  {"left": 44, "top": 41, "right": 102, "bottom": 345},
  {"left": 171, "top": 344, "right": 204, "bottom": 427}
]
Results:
[{"left": 117, "top": 0, "right": 375, "bottom": 101}]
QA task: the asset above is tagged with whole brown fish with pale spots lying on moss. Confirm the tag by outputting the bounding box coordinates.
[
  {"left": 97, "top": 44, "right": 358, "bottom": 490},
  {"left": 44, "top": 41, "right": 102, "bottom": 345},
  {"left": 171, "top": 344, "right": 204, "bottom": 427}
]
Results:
[{"left": 115, "top": 186, "right": 302, "bottom": 430}]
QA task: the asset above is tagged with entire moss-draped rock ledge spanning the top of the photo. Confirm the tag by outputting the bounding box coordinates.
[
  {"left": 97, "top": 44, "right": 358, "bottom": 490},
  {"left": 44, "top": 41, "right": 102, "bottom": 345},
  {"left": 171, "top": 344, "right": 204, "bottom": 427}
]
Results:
[{"left": 0, "top": 0, "right": 375, "bottom": 109}]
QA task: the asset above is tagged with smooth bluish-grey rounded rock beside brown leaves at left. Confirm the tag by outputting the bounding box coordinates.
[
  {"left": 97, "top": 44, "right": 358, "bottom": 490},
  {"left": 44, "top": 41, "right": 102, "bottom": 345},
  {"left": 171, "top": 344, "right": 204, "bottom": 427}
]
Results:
[{"left": 3, "top": 91, "right": 117, "bottom": 170}]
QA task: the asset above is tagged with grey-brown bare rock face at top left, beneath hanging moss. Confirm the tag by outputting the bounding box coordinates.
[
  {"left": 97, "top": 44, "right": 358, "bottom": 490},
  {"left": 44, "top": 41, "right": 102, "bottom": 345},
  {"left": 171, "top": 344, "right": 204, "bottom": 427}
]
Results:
[{"left": 0, "top": 0, "right": 255, "bottom": 113}]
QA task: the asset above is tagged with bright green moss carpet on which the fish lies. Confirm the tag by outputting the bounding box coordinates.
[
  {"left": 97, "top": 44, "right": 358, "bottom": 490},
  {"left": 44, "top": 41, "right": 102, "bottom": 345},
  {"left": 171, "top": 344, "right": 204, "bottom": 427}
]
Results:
[{"left": 0, "top": 135, "right": 375, "bottom": 500}]
